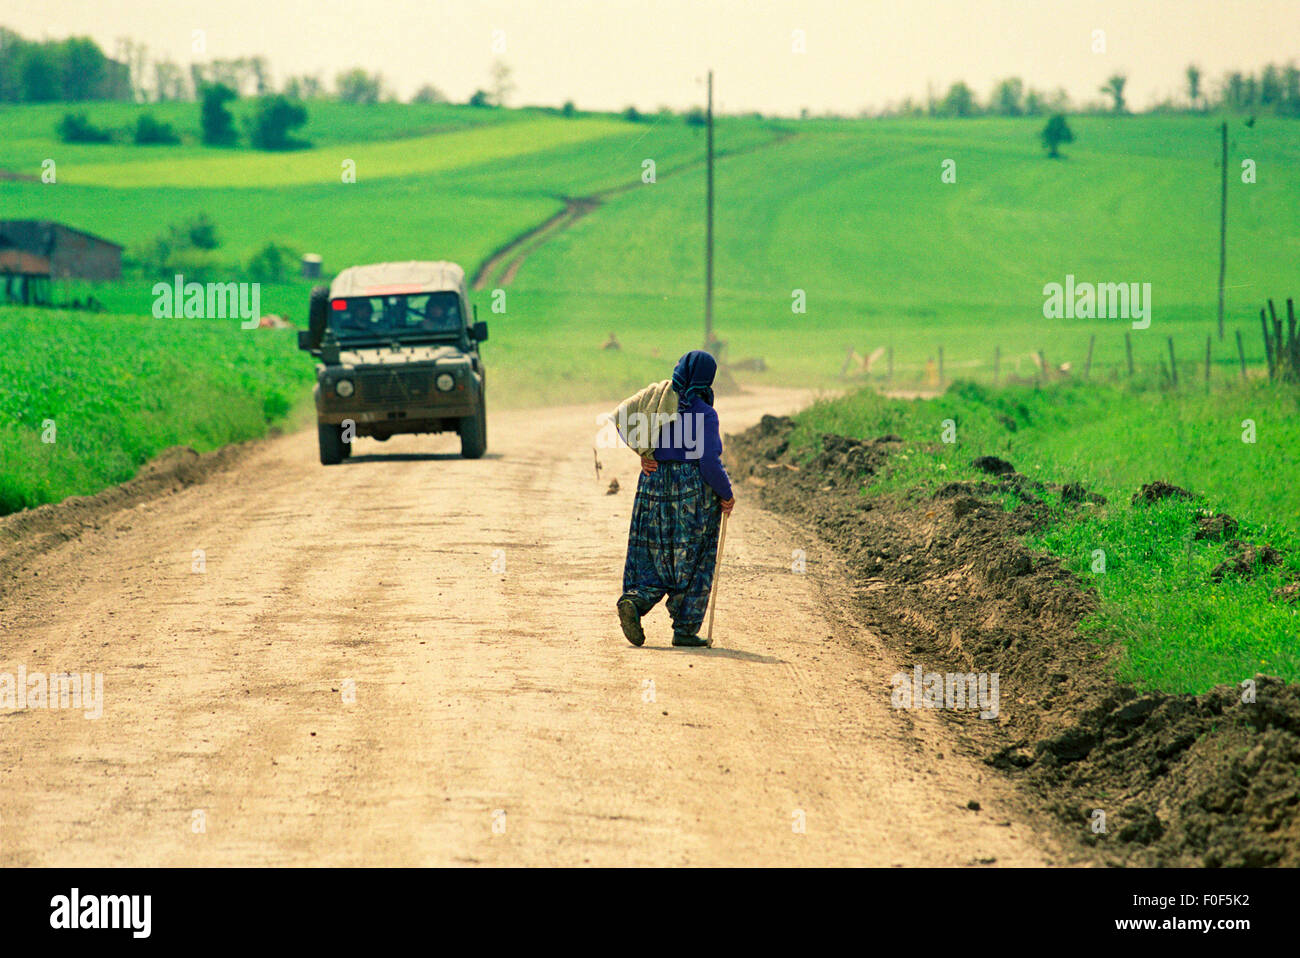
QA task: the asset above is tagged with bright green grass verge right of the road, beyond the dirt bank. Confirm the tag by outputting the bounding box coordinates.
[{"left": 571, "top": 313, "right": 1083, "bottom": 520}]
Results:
[{"left": 774, "top": 383, "right": 1300, "bottom": 692}]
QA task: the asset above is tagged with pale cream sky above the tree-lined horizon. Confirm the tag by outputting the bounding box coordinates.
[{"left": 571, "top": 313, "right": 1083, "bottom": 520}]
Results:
[{"left": 10, "top": 0, "right": 1300, "bottom": 114}]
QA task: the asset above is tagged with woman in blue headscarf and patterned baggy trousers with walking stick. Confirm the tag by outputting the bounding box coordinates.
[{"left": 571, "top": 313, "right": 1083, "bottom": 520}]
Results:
[{"left": 618, "top": 350, "right": 736, "bottom": 646}]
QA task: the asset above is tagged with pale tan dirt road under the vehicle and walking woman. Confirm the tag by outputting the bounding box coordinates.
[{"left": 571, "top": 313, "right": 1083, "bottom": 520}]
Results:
[{"left": 0, "top": 391, "right": 1060, "bottom": 866}]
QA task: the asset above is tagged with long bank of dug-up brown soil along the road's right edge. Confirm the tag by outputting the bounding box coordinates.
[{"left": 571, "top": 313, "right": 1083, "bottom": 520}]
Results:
[{"left": 728, "top": 417, "right": 1300, "bottom": 866}]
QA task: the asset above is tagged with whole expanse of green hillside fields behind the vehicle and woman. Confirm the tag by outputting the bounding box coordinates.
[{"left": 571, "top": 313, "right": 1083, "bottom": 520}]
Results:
[{"left": 0, "top": 104, "right": 1300, "bottom": 395}]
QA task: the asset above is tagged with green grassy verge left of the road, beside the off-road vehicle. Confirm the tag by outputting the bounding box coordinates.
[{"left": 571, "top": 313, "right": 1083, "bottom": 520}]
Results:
[{"left": 0, "top": 308, "right": 311, "bottom": 515}]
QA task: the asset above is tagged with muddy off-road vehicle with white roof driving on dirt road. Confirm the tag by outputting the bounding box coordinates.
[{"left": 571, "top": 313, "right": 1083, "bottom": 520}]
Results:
[{"left": 298, "top": 263, "right": 488, "bottom": 465}]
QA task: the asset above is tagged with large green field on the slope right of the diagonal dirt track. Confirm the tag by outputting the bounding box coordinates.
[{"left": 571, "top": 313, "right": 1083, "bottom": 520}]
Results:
[{"left": 514, "top": 117, "right": 1300, "bottom": 386}]
